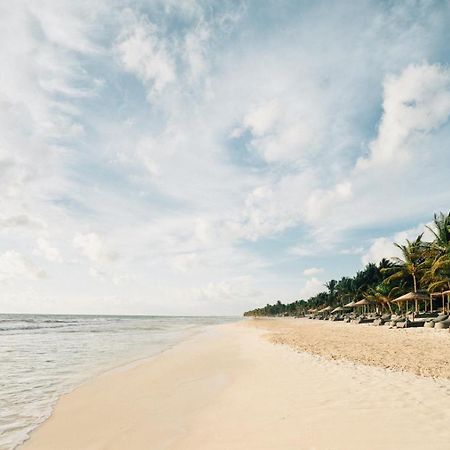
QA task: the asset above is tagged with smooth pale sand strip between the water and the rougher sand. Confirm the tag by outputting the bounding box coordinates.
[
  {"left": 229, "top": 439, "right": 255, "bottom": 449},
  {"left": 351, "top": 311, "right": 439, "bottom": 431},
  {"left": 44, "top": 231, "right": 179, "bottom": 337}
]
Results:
[{"left": 21, "top": 320, "right": 450, "bottom": 450}]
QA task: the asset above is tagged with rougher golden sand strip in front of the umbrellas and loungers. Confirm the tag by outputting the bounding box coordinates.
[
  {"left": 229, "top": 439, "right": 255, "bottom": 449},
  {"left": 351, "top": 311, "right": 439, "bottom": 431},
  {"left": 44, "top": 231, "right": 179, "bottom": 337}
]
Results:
[{"left": 252, "top": 318, "right": 450, "bottom": 378}]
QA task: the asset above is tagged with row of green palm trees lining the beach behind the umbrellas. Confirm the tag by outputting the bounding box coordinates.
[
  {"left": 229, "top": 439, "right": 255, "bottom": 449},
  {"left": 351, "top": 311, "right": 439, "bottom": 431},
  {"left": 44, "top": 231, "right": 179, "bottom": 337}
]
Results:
[{"left": 244, "top": 213, "right": 450, "bottom": 316}]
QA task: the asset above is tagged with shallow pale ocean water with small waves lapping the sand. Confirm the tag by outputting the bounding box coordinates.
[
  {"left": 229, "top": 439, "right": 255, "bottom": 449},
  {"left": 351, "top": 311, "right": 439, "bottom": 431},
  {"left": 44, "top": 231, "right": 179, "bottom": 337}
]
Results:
[{"left": 0, "top": 314, "right": 238, "bottom": 450}]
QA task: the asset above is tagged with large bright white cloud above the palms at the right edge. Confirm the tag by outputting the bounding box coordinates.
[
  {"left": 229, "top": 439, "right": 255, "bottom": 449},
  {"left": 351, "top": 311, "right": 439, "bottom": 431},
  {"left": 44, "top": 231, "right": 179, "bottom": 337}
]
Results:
[{"left": 288, "top": 63, "right": 450, "bottom": 245}]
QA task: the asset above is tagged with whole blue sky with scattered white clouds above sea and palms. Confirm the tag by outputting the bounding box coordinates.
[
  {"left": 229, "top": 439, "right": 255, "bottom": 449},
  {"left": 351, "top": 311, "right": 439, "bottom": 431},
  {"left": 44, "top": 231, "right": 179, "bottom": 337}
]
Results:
[{"left": 0, "top": 0, "right": 450, "bottom": 315}]
